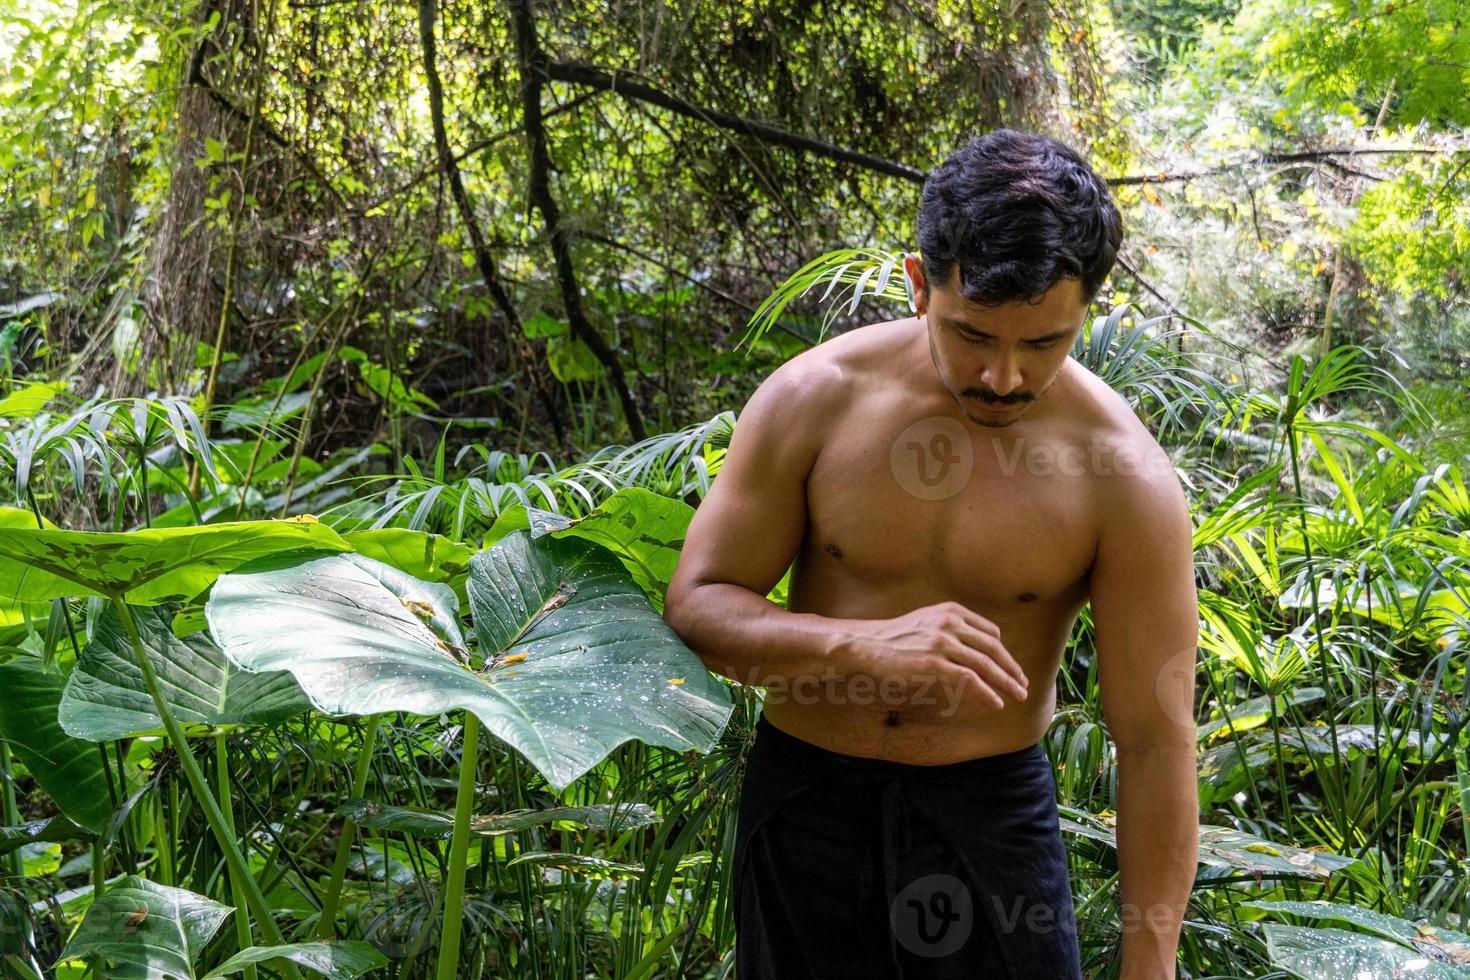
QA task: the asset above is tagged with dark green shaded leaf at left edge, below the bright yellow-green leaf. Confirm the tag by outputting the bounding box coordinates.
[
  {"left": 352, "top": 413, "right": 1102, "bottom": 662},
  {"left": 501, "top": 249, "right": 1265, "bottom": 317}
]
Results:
[{"left": 0, "top": 655, "right": 112, "bottom": 833}]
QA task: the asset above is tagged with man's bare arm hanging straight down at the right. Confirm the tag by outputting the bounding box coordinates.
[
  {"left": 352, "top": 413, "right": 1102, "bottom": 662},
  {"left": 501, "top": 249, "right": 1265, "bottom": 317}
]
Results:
[{"left": 1091, "top": 445, "right": 1200, "bottom": 980}]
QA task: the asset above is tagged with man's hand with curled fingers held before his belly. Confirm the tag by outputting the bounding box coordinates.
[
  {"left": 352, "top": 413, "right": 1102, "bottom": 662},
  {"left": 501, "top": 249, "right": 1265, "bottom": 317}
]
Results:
[{"left": 835, "top": 602, "right": 1029, "bottom": 710}]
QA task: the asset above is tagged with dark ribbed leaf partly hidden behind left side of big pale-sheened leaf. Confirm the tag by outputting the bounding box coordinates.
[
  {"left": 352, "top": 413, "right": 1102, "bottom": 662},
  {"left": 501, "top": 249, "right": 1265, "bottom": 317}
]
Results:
[{"left": 57, "top": 604, "right": 312, "bottom": 742}]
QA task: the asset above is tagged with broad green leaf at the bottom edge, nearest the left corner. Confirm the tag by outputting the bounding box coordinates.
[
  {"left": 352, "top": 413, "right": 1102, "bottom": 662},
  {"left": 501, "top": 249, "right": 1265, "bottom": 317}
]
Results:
[{"left": 62, "top": 874, "right": 234, "bottom": 980}]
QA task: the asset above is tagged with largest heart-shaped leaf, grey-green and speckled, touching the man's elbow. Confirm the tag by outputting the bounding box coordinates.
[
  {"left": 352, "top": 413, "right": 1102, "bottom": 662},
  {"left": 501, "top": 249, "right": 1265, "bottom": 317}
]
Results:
[{"left": 206, "top": 532, "right": 731, "bottom": 789}]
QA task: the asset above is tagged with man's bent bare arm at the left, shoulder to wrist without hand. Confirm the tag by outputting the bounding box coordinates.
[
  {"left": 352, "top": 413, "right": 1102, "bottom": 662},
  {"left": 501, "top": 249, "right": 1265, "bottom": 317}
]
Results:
[{"left": 663, "top": 351, "right": 856, "bottom": 685}]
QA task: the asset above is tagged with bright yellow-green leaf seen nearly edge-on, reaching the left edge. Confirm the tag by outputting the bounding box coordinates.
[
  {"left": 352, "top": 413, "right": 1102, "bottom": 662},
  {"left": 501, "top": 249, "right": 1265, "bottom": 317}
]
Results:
[{"left": 0, "top": 519, "right": 350, "bottom": 605}]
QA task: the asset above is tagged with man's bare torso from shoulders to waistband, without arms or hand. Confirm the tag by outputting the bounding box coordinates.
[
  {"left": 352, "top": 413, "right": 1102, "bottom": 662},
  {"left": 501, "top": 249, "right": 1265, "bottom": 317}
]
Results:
[{"left": 764, "top": 319, "right": 1157, "bottom": 764}]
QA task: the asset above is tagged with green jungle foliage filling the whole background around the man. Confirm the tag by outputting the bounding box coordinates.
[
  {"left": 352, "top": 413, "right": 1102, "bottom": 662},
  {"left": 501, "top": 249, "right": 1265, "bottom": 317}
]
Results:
[{"left": 0, "top": 0, "right": 1470, "bottom": 980}]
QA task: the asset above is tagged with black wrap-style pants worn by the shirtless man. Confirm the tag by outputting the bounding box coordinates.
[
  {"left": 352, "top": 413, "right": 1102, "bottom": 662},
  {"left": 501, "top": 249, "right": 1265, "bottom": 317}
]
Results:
[{"left": 734, "top": 717, "right": 1082, "bottom": 980}]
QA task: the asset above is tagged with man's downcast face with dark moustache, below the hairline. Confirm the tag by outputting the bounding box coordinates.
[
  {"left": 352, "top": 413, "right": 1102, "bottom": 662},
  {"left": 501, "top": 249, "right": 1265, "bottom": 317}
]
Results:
[{"left": 904, "top": 256, "right": 1088, "bottom": 428}]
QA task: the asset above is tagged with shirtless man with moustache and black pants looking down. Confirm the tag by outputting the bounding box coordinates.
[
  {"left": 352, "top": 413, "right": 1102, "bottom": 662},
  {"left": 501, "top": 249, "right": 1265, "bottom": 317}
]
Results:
[{"left": 664, "top": 129, "right": 1198, "bottom": 980}]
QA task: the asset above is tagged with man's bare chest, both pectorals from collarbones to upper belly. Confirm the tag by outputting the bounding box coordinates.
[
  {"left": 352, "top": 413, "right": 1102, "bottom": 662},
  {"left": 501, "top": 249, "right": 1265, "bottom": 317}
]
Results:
[{"left": 804, "top": 416, "right": 1097, "bottom": 611}]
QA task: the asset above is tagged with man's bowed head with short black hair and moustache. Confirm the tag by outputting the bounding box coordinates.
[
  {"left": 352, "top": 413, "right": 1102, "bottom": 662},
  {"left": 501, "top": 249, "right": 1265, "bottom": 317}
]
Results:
[{"left": 904, "top": 129, "right": 1123, "bottom": 426}]
